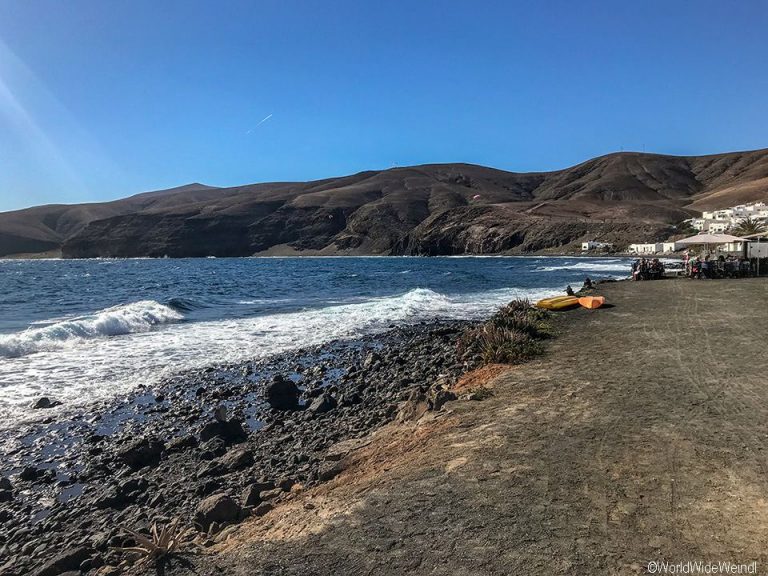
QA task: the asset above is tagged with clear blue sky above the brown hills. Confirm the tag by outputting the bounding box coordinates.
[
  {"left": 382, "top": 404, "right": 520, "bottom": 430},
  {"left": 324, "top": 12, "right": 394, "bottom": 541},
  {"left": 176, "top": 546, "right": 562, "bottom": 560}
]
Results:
[{"left": 0, "top": 0, "right": 768, "bottom": 210}]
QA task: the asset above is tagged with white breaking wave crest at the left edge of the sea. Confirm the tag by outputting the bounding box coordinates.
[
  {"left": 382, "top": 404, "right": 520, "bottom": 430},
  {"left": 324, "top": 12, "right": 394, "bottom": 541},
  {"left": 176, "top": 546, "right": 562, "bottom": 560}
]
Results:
[{"left": 0, "top": 300, "right": 184, "bottom": 358}]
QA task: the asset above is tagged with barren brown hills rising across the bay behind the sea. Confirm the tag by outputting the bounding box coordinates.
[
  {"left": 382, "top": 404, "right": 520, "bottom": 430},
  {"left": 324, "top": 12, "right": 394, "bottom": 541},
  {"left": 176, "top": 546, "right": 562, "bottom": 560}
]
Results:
[{"left": 0, "top": 150, "right": 768, "bottom": 257}]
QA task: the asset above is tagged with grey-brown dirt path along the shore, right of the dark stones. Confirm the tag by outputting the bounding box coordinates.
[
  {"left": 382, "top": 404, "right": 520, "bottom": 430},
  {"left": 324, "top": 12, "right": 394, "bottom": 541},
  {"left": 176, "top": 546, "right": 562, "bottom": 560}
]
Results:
[{"left": 170, "top": 280, "right": 768, "bottom": 575}]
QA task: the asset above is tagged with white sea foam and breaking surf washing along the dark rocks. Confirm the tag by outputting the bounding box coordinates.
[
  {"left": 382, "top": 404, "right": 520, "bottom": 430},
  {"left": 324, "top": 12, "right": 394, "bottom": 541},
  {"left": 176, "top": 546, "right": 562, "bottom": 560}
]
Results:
[{"left": 0, "top": 288, "right": 553, "bottom": 428}]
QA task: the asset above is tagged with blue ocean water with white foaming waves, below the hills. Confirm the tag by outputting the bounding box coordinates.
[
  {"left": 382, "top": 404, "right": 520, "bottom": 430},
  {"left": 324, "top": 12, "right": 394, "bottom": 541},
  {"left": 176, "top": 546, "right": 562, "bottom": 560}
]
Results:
[{"left": 0, "top": 257, "right": 629, "bottom": 428}]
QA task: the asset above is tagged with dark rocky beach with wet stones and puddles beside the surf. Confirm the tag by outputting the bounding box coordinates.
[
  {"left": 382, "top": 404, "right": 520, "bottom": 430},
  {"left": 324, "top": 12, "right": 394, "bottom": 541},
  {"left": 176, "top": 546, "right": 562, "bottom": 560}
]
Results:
[{"left": 0, "top": 322, "right": 488, "bottom": 576}]
